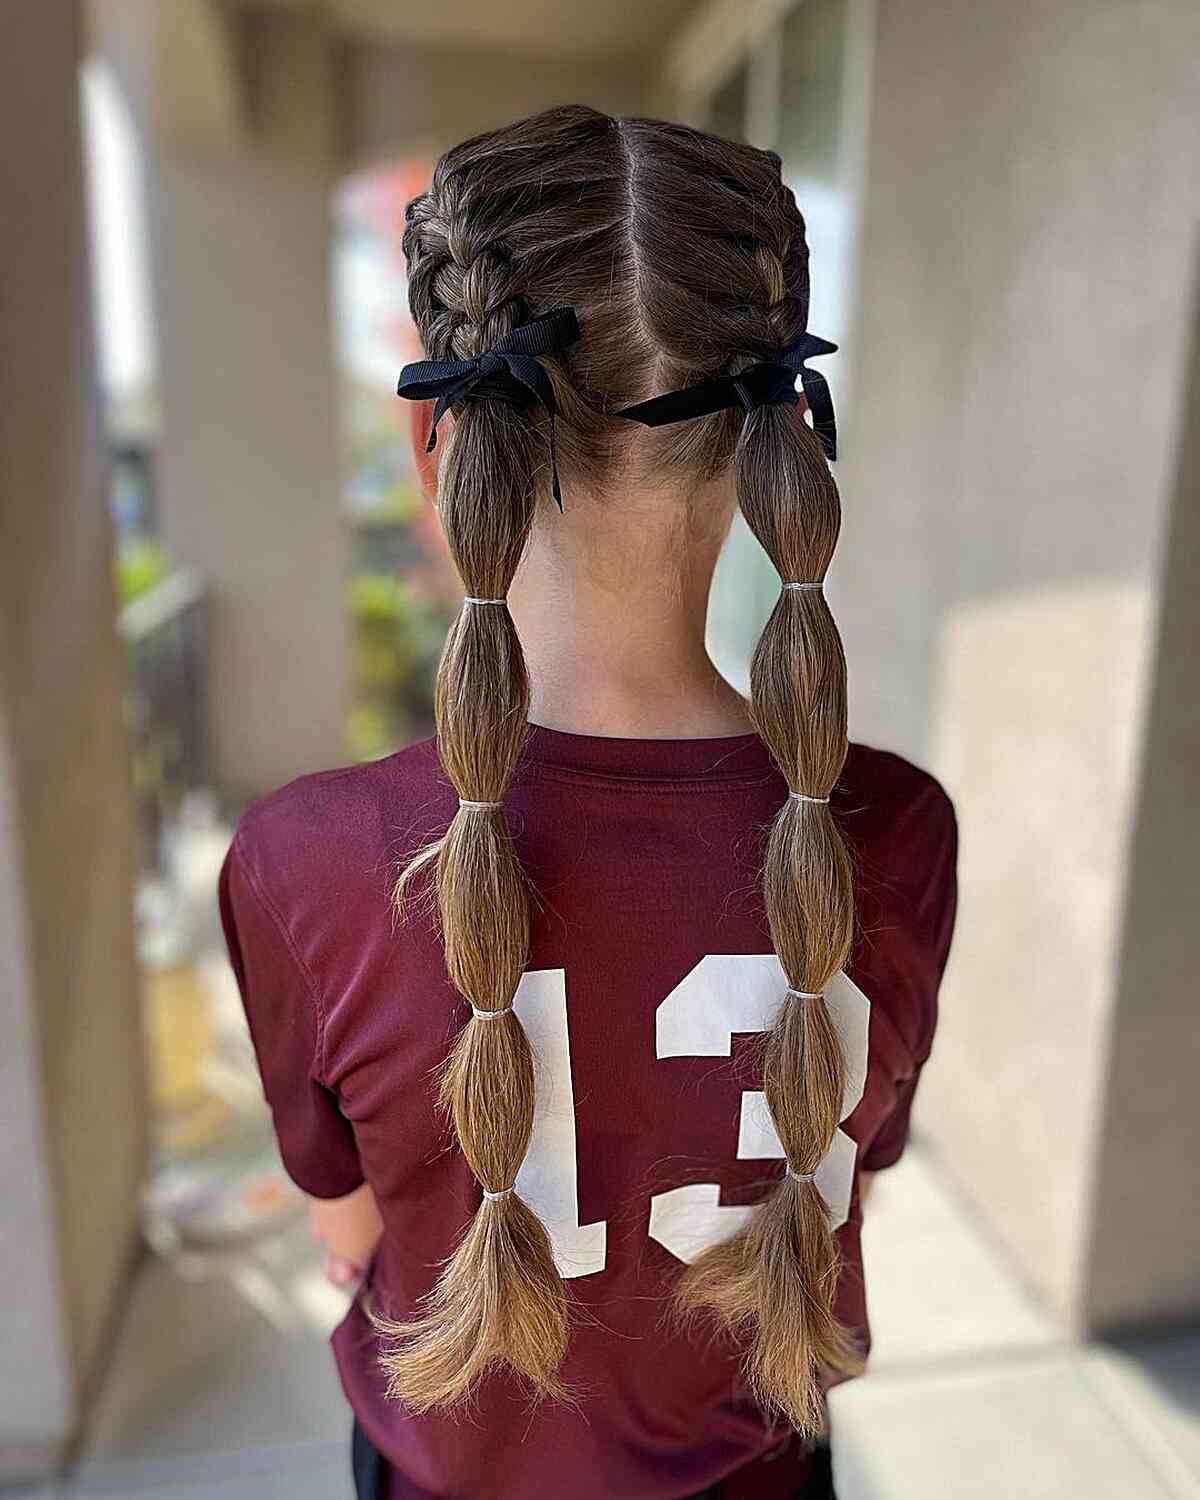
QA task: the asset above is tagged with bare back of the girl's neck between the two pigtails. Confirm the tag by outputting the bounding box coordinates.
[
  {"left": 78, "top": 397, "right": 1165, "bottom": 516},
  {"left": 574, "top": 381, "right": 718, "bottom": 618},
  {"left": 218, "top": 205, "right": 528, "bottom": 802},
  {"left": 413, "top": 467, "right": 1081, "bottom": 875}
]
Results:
[{"left": 509, "top": 485, "right": 750, "bottom": 740}]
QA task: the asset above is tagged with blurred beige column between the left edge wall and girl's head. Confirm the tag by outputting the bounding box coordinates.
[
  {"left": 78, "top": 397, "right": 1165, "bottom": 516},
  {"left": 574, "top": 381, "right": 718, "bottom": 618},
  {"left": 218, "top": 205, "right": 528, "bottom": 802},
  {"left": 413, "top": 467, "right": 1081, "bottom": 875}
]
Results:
[{"left": 147, "top": 15, "right": 350, "bottom": 797}]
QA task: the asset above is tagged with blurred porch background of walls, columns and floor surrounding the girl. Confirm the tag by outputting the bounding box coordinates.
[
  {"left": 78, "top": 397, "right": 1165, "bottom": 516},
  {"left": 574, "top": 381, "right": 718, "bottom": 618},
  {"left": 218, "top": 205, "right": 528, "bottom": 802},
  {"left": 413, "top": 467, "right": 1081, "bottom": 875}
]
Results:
[{"left": 0, "top": 0, "right": 1200, "bottom": 1500}]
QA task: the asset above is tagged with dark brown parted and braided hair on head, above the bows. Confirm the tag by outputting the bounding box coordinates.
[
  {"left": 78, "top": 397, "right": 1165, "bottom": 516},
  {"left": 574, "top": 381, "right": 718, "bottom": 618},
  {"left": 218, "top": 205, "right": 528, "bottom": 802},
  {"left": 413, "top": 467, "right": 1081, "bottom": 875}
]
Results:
[{"left": 405, "top": 107, "right": 809, "bottom": 479}]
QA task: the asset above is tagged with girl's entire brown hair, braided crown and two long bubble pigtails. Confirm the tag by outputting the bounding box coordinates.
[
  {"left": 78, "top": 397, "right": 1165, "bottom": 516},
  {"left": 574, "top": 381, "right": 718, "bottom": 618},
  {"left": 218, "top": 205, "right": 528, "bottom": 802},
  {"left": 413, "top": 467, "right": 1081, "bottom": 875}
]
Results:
[{"left": 378, "top": 107, "right": 858, "bottom": 1431}]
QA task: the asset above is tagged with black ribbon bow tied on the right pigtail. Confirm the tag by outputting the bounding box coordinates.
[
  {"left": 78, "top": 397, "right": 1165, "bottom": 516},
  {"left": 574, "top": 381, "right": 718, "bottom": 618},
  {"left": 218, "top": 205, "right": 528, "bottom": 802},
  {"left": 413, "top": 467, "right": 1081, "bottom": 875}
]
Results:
[{"left": 617, "top": 333, "right": 837, "bottom": 459}]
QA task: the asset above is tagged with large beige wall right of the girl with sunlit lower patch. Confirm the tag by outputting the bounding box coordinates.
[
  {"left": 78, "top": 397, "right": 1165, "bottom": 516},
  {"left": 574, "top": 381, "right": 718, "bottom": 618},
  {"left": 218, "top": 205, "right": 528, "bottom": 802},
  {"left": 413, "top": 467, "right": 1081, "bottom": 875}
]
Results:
[{"left": 839, "top": 0, "right": 1200, "bottom": 1325}]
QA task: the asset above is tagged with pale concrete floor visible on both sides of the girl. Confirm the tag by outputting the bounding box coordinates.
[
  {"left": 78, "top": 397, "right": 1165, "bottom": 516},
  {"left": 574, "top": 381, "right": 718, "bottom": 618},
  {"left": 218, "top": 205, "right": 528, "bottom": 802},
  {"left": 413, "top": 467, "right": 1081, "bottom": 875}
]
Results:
[{"left": 11, "top": 1148, "right": 1200, "bottom": 1500}]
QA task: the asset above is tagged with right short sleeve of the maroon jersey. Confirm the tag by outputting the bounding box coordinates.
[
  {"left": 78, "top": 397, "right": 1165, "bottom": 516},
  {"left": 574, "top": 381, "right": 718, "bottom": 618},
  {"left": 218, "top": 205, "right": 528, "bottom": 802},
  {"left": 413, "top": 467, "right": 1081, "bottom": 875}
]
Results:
[{"left": 860, "top": 779, "right": 959, "bottom": 1172}]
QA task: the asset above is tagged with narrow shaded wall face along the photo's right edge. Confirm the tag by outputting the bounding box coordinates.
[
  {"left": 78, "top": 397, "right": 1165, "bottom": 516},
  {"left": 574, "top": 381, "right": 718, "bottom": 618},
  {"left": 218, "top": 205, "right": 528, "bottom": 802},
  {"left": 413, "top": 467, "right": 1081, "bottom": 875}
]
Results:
[{"left": 1085, "top": 257, "right": 1200, "bottom": 1328}]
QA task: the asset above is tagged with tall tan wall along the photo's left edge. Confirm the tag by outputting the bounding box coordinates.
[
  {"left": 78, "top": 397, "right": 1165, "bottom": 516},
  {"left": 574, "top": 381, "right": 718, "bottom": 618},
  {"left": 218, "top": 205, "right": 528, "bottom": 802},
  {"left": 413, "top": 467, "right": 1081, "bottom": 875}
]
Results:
[{"left": 0, "top": 0, "right": 146, "bottom": 1479}]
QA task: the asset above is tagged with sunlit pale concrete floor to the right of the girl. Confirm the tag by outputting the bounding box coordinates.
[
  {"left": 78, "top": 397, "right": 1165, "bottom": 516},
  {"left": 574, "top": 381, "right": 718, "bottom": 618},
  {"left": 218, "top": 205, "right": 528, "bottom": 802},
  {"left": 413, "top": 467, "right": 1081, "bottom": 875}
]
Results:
[{"left": 833, "top": 1151, "right": 1200, "bottom": 1500}]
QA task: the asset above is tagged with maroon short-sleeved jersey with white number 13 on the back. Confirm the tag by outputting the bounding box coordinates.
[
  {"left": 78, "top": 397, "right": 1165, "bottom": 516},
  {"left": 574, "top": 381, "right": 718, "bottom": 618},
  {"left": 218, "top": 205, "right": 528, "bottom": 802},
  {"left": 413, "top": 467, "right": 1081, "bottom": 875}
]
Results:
[{"left": 221, "top": 728, "right": 956, "bottom": 1500}]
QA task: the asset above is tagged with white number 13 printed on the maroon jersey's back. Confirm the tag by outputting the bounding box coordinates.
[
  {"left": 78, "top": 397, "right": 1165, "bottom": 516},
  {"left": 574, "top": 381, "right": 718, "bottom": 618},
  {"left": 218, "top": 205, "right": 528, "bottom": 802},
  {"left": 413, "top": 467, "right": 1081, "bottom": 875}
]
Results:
[{"left": 513, "top": 953, "right": 870, "bottom": 1277}]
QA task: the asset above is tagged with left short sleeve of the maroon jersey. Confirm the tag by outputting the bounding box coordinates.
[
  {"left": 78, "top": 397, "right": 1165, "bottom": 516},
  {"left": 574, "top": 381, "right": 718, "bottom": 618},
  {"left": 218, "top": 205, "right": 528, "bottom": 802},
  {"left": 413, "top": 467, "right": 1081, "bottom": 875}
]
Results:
[{"left": 218, "top": 834, "right": 363, "bottom": 1199}]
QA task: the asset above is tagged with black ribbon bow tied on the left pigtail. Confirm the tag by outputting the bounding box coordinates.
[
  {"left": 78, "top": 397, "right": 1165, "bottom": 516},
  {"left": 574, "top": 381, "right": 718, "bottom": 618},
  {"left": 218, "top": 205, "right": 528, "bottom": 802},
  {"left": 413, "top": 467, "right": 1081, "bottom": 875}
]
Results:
[{"left": 396, "top": 308, "right": 579, "bottom": 510}]
